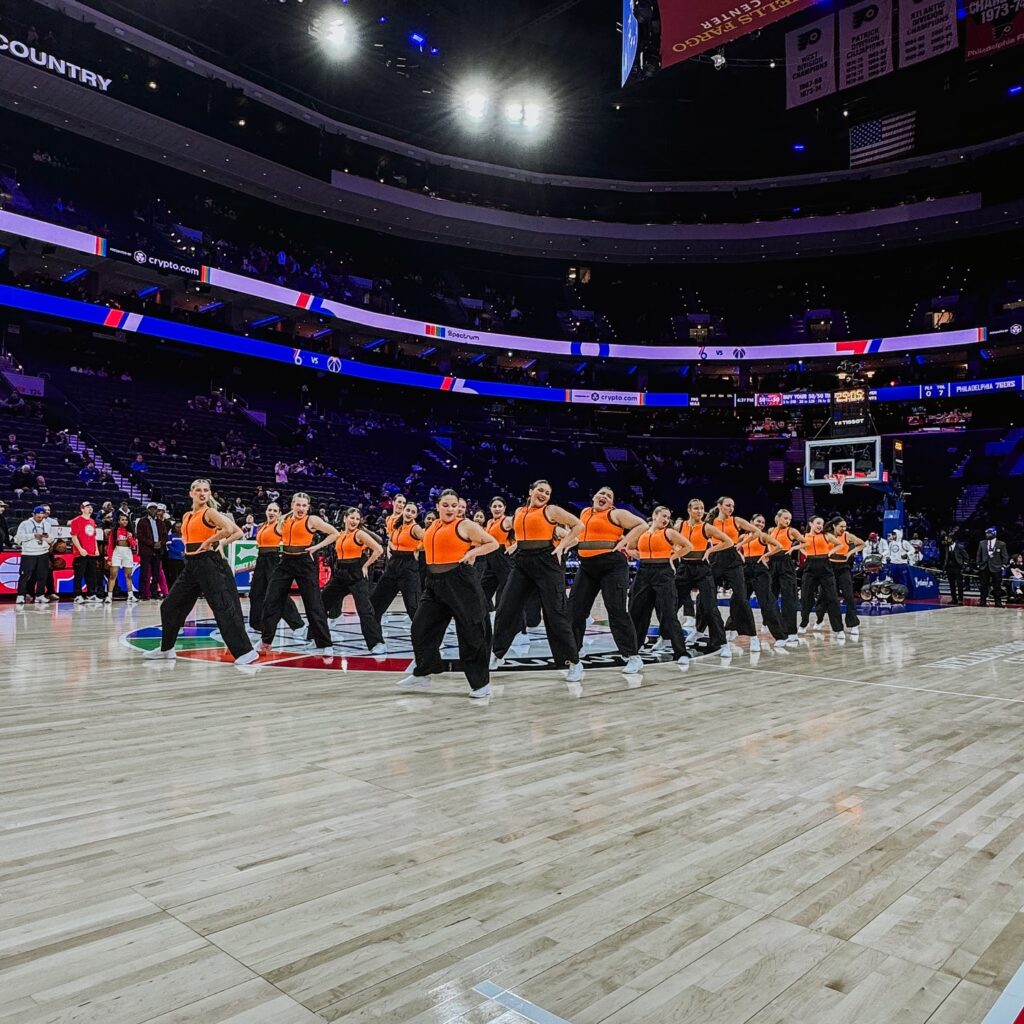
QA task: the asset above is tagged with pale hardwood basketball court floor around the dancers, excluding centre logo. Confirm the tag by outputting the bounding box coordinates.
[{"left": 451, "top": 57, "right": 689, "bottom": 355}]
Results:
[{"left": 0, "top": 603, "right": 1024, "bottom": 1024}]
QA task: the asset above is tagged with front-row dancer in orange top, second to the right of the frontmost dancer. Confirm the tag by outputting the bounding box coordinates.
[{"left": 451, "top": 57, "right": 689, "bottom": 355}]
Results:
[{"left": 568, "top": 486, "right": 646, "bottom": 675}]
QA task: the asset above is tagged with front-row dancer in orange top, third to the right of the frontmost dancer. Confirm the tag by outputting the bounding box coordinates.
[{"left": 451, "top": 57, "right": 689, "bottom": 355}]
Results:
[{"left": 627, "top": 505, "right": 693, "bottom": 665}]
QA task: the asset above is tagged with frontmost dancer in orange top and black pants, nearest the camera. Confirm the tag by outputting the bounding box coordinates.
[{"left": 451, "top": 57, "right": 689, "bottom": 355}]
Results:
[{"left": 398, "top": 489, "right": 498, "bottom": 699}]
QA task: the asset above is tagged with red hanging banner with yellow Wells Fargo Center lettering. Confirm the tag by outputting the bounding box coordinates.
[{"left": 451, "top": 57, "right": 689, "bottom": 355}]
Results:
[{"left": 658, "top": 0, "right": 814, "bottom": 68}]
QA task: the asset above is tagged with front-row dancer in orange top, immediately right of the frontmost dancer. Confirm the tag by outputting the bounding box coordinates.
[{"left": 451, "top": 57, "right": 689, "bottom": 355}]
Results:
[{"left": 490, "top": 480, "right": 583, "bottom": 686}]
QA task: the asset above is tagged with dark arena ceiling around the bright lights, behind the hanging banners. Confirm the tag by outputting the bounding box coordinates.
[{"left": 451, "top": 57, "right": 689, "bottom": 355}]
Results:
[{"left": 25, "top": 0, "right": 1024, "bottom": 179}]
